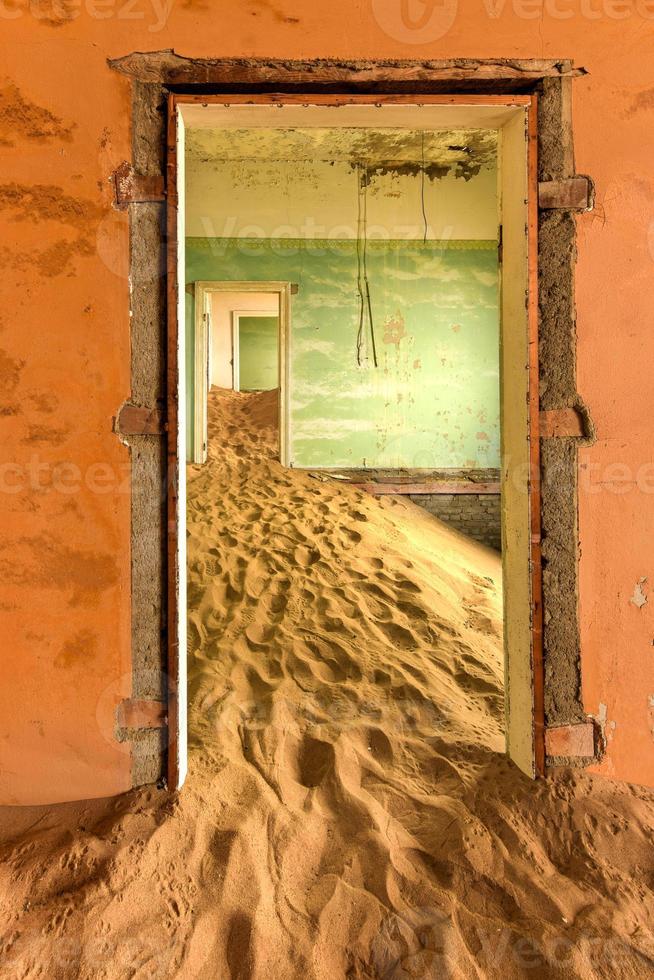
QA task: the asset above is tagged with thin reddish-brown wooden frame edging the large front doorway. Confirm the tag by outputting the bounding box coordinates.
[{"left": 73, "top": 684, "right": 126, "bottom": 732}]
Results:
[{"left": 166, "top": 86, "right": 545, "bottom": 788}]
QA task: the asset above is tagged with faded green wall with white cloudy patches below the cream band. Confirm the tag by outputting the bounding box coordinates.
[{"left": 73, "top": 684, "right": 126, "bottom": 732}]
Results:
[{"left": 186, "top": 238, "right": 499, "bottom": 468}]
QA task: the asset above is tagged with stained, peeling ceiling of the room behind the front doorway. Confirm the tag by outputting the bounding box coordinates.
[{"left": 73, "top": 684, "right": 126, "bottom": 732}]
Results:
[{"left": 186, "top": 127, "right": 497, "bottom": 180}]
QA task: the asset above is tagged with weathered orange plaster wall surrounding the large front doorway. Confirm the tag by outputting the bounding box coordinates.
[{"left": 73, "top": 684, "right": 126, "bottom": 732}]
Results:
[{"left": 0, "top": 0, "right": 654, "bottom": 801}]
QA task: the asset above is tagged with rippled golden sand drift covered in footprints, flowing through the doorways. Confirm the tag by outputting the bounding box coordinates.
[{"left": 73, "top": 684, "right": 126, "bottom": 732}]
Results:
[{"left": 0, "top": 391, "right": 654, "bottom": 980}]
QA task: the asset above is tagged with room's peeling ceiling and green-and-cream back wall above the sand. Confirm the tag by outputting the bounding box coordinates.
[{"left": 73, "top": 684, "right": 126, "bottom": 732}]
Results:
[{"left": 185, "top": 112, "right": 501, "bottom": 550}]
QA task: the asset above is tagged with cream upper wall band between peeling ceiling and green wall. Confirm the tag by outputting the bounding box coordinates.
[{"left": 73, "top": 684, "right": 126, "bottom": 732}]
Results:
[{"left": 186, "top": 158, "right": 498, "bottom": 240}]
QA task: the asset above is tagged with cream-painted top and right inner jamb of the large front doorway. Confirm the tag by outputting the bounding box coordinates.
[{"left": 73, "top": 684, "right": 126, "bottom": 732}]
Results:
[{"left": 169, "top": 97, "right": 542, "bottom": 792}]
